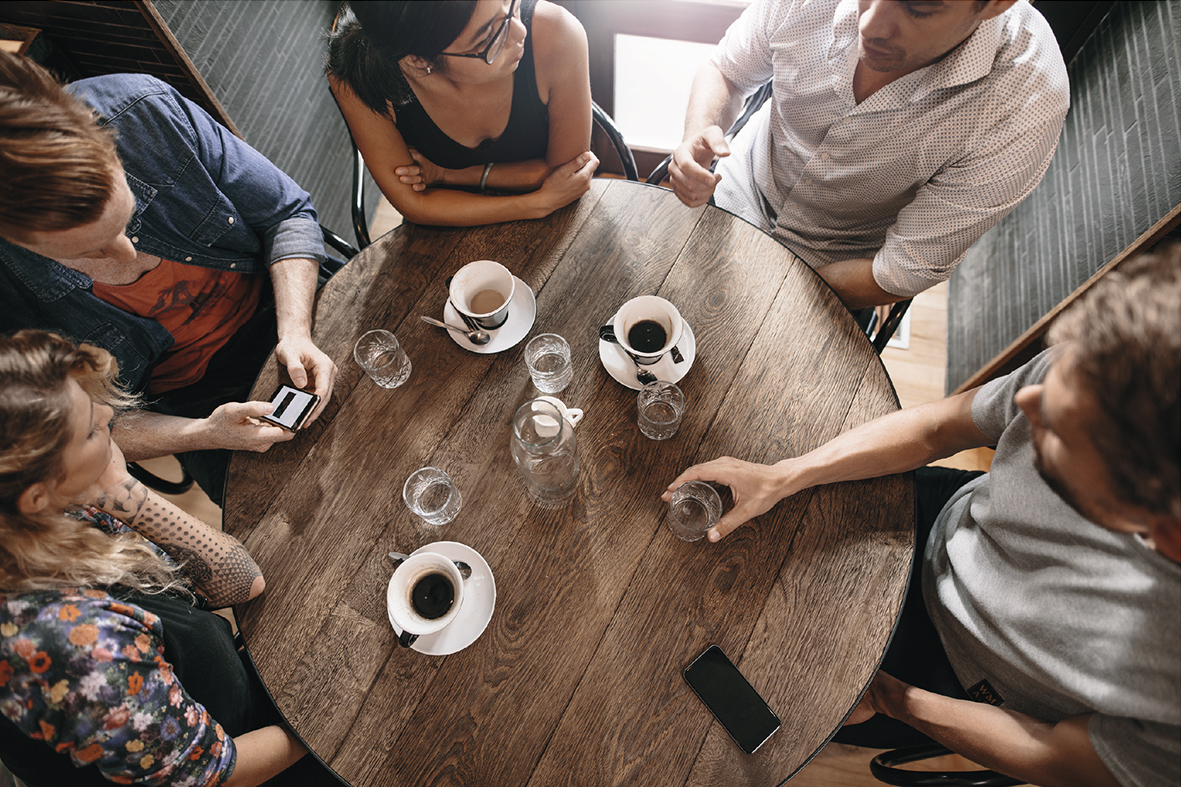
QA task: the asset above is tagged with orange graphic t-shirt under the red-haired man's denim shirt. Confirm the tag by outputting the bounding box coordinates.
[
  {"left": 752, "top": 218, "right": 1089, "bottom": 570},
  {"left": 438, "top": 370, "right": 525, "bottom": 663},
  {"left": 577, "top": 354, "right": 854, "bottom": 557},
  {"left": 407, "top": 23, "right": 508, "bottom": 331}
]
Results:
[{"left": 93, "top": 259, "right": 265, "bottom": 395}]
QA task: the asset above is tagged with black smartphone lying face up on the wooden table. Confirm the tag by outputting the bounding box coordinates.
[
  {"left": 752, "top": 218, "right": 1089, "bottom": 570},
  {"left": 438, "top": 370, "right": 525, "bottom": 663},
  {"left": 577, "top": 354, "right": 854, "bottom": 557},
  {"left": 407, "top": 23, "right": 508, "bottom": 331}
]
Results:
[{"left": 685, "top": 645, "right": 779, "bottom": 754}]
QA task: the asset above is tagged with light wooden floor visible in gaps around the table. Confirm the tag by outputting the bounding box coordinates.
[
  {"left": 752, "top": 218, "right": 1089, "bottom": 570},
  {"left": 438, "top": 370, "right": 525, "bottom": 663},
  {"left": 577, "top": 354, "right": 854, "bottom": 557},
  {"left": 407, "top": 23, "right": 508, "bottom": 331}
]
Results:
[{"left": 142, "top": 200, "right": 992, "bottom": 787}]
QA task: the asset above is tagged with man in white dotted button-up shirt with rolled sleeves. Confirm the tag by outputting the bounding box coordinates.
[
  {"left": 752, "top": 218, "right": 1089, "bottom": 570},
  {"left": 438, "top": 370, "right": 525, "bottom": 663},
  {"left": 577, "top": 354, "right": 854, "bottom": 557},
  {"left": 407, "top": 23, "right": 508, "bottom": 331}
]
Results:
[{"left": 668, "top": 0, "right": 1070, "bottom": 308}]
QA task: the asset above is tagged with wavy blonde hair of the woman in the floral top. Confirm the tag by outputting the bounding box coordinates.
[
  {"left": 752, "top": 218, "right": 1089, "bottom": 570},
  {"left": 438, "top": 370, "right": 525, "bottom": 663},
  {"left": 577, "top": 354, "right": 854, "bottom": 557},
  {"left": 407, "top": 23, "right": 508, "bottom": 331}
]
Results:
[{"left": 0, "top": 330, "right": 184, "bottom": 592}]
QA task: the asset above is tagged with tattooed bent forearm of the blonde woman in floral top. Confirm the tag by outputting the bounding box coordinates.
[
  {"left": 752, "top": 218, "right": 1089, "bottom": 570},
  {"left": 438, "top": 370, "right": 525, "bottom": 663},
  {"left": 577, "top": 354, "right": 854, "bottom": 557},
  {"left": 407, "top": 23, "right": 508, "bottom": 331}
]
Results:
[{"left": 90, "top": 442, "right": 265, "bottom": 607}]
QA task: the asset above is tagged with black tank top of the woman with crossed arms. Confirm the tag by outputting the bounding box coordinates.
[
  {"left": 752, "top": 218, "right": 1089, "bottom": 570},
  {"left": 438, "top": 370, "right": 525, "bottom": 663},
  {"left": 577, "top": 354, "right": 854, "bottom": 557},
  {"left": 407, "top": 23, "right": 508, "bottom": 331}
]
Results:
[{"left": 394, "top": 0, "right": 549, "bottom": 169}]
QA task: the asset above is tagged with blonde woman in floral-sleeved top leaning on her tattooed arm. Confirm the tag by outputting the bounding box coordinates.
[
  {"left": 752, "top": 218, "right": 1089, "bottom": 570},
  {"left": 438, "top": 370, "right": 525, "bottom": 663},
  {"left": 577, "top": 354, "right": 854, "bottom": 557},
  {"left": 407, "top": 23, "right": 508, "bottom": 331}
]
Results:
[{"left": 0, "top": 330, "right": 335, "bottom": 787}]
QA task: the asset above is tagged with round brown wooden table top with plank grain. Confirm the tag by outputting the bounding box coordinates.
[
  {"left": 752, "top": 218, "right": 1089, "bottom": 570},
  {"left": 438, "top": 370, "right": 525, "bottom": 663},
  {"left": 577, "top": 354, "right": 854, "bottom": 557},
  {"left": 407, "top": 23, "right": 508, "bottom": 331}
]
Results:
[{"left": 224, "top": 180, "right": 914, "bottom": 787}]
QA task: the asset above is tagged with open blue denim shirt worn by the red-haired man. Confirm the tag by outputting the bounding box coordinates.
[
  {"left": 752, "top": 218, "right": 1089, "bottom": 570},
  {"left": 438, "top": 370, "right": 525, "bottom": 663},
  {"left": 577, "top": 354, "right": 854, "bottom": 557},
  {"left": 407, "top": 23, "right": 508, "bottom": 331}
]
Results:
[{"left": 0, "top": 74, "right": 325, "bottom": 389}]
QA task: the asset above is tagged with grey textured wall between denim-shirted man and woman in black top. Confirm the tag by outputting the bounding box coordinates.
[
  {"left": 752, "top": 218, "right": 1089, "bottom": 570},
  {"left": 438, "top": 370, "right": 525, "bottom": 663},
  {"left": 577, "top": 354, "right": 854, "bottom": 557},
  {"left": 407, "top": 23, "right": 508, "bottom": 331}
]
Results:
[{"left": 155, "top": 0, "right": 378, "bottom": 242}]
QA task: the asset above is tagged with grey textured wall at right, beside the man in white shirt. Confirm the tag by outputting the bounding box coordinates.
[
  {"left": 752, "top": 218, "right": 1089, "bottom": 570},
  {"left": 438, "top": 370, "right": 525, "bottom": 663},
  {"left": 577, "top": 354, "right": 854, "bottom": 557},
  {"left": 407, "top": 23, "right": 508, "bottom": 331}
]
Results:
[{"left": 947, "top": 0, "right": 1181, "bottom": 391}]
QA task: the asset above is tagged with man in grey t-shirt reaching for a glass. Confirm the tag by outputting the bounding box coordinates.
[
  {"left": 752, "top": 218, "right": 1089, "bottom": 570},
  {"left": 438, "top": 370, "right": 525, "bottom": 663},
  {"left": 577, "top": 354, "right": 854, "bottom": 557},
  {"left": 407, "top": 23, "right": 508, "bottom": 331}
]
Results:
[{"left": 666, "top": 245, "right": 1181, "bottom": 787}]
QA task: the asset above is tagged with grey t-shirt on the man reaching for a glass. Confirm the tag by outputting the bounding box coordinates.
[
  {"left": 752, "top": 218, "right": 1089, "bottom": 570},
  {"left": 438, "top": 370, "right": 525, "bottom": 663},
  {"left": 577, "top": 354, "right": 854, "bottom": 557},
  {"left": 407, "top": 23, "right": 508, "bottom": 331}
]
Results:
[{"left": 922, "top": 350, "right": 1181, "bottom": 785}]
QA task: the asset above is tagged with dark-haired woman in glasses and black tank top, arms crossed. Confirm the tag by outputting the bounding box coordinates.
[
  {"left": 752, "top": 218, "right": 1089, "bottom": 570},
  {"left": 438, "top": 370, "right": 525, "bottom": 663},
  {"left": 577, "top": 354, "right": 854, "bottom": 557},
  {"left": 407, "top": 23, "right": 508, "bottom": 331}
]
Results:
[{"left": 326, "top": 0, "right": 599, "bottom": 227}]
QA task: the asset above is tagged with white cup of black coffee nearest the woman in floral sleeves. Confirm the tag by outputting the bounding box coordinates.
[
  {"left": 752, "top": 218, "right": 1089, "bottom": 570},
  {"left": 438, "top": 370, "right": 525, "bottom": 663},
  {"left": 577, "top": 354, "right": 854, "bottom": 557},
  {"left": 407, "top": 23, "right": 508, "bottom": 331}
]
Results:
[{"left": 386, "top": 552, "right": 463, "bottom": 648}]
